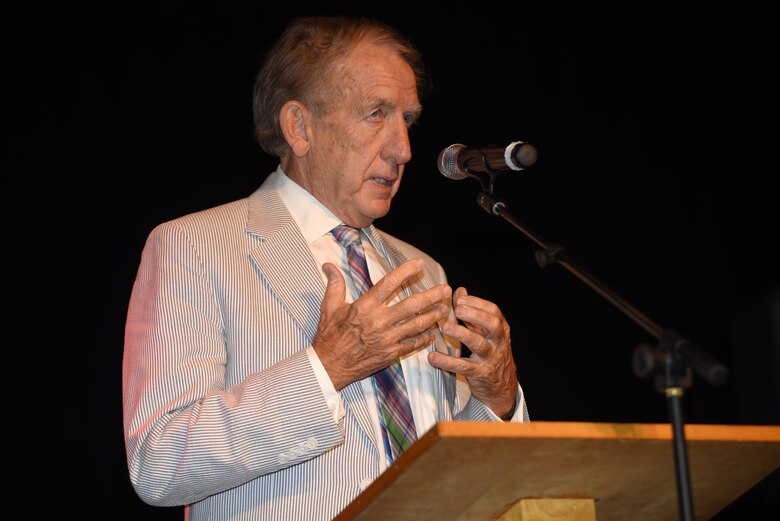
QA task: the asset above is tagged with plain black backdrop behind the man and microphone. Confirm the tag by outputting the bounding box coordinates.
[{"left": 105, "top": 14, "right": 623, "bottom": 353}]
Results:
[{"left": 13, "top": 1, "right": 780, "bottom": 520}]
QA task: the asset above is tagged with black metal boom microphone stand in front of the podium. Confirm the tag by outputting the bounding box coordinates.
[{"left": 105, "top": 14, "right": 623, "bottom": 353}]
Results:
[{"left": 466, "top": 164, "right": 728, "bottom": 521}]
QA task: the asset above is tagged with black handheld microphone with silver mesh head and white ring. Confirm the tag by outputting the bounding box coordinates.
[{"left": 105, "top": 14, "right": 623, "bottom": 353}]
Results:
[{"left": 438, "top": 141, "right": 537, "bottom": 180}]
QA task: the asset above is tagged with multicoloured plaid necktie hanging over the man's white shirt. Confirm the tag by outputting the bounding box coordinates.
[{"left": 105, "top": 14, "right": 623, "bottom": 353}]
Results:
[{"left": 331, "top": 225, "right": 417, "bottom": 463}]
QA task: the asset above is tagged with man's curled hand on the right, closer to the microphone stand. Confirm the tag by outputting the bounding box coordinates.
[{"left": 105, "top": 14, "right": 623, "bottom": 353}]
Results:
[{"left": 428, "top": 288, "right": 518, "bottom": 418}]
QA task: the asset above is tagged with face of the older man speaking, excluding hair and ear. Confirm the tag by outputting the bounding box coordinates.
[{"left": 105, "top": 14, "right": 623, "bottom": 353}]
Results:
[{"left": 295, "top": 43, "right": 421, "bottom": 227}]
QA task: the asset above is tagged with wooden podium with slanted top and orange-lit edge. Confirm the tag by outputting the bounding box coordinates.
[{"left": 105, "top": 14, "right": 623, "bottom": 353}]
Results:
[{"left": 335, "top": 421, "right": 780, "bottom": 521}]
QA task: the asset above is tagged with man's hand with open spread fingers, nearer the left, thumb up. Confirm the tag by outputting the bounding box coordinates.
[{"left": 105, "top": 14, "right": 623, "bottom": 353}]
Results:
[{"left": 312, "top": 259, "right": 452, "bottom": 390}]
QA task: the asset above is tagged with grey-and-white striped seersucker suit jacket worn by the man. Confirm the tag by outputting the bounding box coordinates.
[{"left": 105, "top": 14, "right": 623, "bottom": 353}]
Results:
[{"left": 123, "top": 173, "right": 528, "bottom": 521}]
